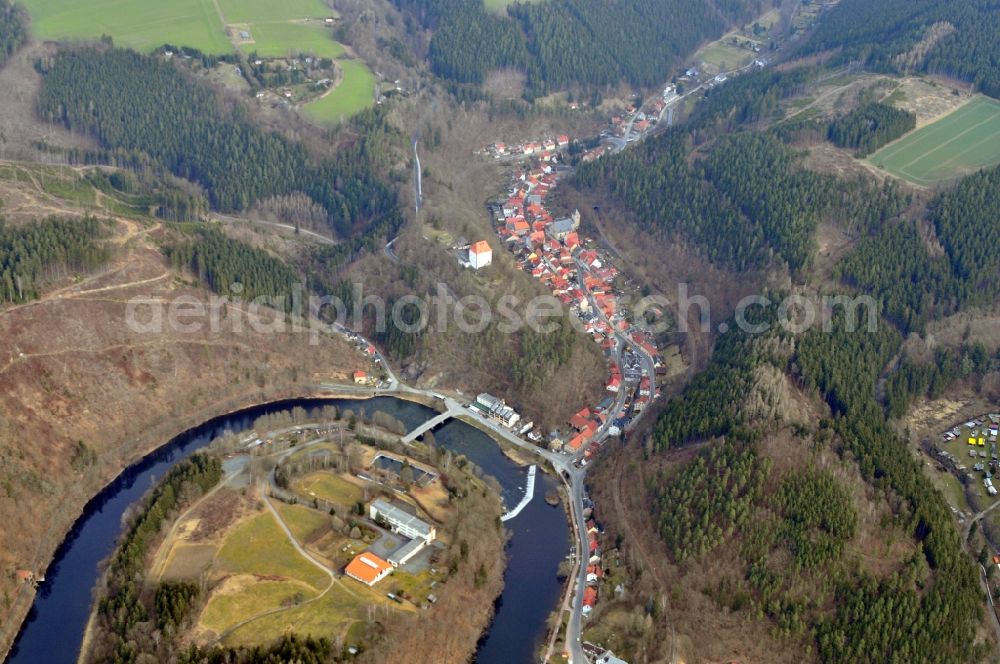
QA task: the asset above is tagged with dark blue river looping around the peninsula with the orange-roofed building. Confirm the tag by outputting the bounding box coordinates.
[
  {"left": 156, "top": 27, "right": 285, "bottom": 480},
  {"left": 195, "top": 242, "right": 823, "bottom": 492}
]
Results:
[{"left": 7, "top": 397, "right": 569, "bottom": 664}]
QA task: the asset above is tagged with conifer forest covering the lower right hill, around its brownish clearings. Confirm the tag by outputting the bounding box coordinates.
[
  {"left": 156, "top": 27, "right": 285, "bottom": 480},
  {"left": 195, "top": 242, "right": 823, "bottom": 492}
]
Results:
[{"left": 640, "top": 294, "right": 981, "bottom": 663}]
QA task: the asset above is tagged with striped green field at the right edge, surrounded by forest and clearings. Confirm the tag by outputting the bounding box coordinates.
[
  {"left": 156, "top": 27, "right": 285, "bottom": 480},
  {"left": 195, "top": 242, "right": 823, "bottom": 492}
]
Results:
[{"left": 868, "top": 96, "right": 1000, "bottom": 186}]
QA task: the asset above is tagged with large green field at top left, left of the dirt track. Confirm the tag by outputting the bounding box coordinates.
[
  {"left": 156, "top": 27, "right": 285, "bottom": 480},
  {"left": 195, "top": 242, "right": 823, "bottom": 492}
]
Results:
[{"left": 21, "top": 0, "right": 233, "bottom": 53}]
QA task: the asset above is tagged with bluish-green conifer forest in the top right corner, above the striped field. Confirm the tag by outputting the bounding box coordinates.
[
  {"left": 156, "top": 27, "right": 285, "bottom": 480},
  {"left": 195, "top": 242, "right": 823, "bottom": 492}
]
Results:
[{"left": 803, "top": 0, "right": 1000, "bottom": 97}]
